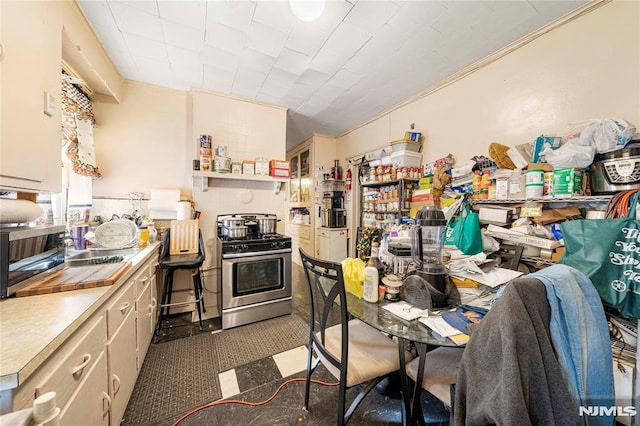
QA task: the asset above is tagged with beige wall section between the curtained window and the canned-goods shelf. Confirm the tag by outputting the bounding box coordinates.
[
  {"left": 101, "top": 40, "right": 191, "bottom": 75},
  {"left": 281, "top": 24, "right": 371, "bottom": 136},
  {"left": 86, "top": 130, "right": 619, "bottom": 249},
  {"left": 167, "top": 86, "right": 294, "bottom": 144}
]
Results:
[{"left": 93, "top": 82, "right": 193, "bottom": 199}]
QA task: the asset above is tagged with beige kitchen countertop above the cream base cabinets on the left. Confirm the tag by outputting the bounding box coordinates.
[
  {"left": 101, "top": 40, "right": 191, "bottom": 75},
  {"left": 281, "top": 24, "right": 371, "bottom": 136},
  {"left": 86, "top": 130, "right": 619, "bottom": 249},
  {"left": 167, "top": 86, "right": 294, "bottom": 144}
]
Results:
[{"left": 0, "top": 243, "right": 160, "bottom": 391}]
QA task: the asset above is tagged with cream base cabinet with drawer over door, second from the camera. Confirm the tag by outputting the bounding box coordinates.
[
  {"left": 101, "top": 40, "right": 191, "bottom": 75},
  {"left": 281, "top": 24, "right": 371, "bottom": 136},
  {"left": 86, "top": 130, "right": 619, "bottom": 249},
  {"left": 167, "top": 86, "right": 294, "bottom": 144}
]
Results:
[{"left": 107, "top": 281, "right": 138, "bottom": 426}]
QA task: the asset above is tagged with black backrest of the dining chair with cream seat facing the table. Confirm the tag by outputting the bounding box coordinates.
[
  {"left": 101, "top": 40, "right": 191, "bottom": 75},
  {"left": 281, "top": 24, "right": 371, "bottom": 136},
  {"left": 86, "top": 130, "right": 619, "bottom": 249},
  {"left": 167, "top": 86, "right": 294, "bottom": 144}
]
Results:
[{"left": 300, "top": 249, "right": 349, "bottom": 372}]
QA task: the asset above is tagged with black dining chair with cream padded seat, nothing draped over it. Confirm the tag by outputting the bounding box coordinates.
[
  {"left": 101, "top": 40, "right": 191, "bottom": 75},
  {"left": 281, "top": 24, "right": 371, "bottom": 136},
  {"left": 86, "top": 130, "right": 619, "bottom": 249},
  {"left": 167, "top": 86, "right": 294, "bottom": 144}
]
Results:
[{"left": 300, "top": 249, "right": 400, "bottom": 425}]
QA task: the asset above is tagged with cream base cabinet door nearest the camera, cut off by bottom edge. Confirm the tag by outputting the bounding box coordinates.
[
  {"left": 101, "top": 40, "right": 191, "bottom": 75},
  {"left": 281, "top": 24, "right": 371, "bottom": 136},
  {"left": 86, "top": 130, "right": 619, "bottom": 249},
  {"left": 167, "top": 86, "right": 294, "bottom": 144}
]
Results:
[{"left": 60, "top": 350, "right": 111, "bottom": 426}]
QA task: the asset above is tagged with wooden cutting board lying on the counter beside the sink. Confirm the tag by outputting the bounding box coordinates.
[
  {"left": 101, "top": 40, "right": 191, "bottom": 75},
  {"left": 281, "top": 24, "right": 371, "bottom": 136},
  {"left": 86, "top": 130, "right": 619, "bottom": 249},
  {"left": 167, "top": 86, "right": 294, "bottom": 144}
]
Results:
[{"left": 16, "top": 262, "right": 131, "bottom": 297}]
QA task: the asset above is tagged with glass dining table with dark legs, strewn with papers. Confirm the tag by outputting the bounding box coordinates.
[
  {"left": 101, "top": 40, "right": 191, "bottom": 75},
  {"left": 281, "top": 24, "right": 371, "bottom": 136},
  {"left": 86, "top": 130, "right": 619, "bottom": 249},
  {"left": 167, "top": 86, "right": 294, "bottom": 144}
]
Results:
[{"left": 346, "top": 292, "right": 459, "bottom": 425}]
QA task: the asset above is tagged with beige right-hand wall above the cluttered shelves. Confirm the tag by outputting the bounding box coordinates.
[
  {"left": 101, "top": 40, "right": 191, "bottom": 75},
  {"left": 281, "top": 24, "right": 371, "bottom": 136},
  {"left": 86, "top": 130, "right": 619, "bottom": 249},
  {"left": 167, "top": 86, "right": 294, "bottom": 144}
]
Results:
[{"left": 338, "top": 0, "right": 640, "bottom": 162}]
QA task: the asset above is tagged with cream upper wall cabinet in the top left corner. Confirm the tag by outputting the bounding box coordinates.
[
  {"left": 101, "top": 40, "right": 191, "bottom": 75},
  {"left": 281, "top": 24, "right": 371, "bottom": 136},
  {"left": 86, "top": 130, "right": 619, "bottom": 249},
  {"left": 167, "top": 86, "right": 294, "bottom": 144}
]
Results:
[{"left": 0, "top": 1, "right": 62, "bottom": 192}]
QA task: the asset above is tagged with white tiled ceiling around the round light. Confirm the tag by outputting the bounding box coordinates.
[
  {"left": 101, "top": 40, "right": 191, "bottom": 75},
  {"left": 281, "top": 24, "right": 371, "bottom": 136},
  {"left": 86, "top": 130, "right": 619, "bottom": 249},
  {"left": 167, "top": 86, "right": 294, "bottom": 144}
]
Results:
[{"left": 78, "top": 0, "right": 586, "bottom": 148}]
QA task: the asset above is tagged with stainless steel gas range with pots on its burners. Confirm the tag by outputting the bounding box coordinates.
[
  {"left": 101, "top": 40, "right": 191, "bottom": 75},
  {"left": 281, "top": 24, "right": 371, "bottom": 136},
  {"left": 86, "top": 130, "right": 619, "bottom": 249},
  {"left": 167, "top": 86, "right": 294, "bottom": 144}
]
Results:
[{"left": 217, "top": 213, "right": 292, "bottom": 329}]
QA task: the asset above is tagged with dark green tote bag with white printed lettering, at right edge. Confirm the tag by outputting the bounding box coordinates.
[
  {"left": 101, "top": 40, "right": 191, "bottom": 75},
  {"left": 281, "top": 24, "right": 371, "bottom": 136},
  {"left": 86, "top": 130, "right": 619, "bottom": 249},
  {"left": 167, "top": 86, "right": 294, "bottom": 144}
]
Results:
[{"left": 560, "top": 194, "right": 640, "bottom": 318}]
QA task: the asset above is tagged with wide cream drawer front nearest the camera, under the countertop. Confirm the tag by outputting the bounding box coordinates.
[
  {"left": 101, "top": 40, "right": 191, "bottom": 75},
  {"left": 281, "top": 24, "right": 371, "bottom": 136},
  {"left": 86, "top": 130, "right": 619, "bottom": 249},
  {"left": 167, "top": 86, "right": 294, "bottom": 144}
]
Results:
[{"left": 35, "top": 316, "right": 107, "bottom": 408}]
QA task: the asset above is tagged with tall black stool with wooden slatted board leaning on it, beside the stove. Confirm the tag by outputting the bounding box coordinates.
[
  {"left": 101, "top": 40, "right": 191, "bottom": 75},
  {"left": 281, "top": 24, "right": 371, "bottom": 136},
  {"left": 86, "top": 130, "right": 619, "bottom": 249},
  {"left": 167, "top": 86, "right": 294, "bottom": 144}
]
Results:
[{"left": 156, "top": 220, "right": 205, "bottom": 334}]
